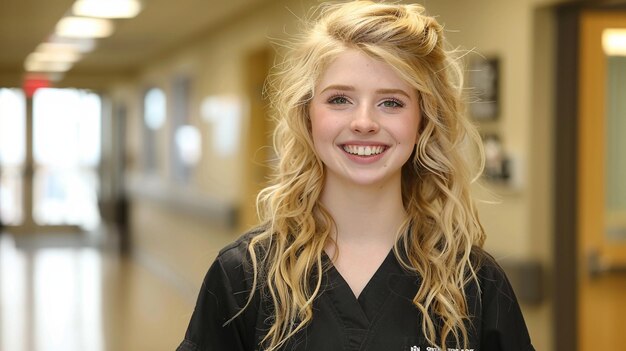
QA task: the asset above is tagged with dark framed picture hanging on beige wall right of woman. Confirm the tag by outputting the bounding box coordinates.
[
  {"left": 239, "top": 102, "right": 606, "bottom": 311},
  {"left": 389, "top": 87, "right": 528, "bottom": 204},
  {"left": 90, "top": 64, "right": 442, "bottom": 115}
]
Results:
[{"left": 468, "top": 58, "right": 500, "bottom": 121}]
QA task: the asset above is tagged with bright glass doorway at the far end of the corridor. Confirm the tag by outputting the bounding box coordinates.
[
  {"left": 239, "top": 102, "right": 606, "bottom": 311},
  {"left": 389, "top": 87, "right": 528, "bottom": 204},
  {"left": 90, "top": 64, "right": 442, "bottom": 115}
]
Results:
[{"left": 0, "top": 88, "right": 102, "bottom": 234}]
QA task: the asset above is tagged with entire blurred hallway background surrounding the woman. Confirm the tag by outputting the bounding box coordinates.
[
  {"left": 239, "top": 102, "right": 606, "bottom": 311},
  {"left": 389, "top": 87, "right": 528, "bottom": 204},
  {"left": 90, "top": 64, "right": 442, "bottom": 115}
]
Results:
[{"left": 0, "top": 0, "right": 626, "bottom": 351}]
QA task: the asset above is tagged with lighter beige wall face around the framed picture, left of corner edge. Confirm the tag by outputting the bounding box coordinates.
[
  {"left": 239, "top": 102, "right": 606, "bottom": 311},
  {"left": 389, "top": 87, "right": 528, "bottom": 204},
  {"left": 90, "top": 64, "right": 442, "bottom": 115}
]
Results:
[{"left": 426, "top": 0, "right": 533, "bottom": 258}]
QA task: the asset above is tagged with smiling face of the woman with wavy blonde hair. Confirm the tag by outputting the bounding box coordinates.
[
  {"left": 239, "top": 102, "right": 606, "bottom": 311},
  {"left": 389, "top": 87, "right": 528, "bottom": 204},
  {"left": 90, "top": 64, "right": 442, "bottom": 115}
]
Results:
[{"left": 309, "top": 50, "right": 420, "bottom": 187}]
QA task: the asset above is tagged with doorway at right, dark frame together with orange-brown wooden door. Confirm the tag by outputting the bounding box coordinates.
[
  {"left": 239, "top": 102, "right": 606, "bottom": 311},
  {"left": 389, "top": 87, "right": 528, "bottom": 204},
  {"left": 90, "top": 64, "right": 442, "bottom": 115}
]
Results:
[{"left": 553, "top": 3, "right": 626, "bottom": 350}]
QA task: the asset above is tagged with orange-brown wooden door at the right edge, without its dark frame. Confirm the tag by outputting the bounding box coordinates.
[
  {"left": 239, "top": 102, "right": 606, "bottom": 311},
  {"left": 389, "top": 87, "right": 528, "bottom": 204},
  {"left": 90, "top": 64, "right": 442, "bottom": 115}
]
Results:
[{"left": 576, "top": 10, "right": 626, "bottom": 350}]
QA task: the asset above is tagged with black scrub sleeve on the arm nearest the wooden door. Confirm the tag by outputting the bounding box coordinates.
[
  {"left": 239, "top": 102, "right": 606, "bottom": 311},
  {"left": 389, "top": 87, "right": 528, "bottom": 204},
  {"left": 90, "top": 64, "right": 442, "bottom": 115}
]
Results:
[{"left": 478, "top": 256, "right": 535, "bottom": 351}]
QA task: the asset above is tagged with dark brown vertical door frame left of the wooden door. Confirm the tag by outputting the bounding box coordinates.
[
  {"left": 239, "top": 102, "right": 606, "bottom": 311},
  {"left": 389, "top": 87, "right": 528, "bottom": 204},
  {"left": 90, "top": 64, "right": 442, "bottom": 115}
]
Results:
[{"left": 552, "top": 4, "right": 582, "bottom": 350}]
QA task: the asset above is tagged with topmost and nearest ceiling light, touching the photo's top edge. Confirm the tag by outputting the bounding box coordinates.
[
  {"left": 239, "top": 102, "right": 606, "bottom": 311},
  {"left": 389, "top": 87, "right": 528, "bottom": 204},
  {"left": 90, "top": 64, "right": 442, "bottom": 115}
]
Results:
[{"left": 72, "top": 0, "right": 141, "bottom": 18}]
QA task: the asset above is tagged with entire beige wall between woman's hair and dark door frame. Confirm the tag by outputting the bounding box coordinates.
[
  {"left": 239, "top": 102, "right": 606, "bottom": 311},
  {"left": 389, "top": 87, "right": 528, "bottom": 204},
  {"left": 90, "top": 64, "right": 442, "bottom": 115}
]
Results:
[{"left": 426, "top": 0, "right": 556, "bottom": 350}]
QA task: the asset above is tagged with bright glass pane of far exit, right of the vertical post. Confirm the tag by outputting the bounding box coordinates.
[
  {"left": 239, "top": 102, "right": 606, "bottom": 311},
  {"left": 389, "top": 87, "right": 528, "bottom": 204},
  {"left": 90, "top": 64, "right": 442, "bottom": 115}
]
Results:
[{"left": 33, "top": 89, "right": 102, "bottom": 229}]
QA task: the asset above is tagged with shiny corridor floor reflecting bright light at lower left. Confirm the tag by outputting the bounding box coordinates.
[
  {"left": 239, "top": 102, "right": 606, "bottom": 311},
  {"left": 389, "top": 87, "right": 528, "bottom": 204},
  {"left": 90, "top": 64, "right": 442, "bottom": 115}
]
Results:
[{"left": 0, "top": 234, "right": 193, "bottom": 351}]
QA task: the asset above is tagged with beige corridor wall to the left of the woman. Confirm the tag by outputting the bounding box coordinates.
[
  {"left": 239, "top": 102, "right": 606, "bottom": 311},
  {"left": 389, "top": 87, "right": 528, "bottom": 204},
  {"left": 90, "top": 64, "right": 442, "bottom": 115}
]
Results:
[{"left": 110, "top": 1, "right": 312, "bottom": 310}]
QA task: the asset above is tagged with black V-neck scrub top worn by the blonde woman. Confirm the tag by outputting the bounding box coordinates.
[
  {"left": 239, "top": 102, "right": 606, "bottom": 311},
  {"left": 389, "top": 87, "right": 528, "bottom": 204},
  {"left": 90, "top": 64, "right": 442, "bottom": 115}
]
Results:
[{"left": 177, "top": 233, "right": 534, "bottom": 351}]
